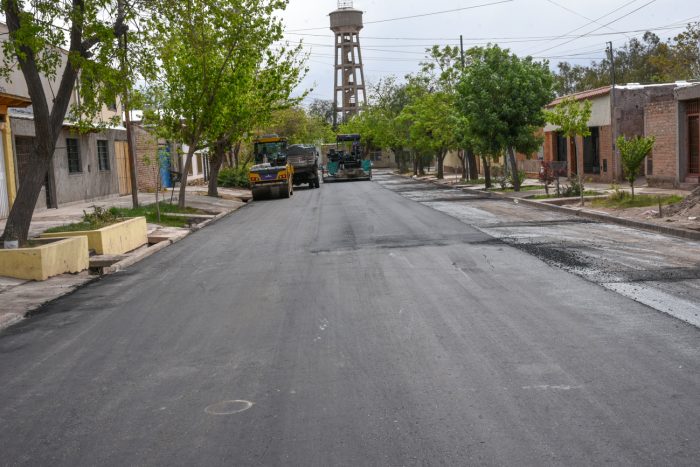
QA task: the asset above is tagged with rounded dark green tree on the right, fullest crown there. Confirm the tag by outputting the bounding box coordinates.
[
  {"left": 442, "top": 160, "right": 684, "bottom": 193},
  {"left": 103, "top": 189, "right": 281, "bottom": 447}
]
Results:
[{"left": 457, "top": 45, "right": 554, "bottom": 191}]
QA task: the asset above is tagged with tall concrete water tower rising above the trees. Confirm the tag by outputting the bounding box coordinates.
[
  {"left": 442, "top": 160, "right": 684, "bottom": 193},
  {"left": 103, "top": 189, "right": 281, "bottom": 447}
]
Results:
[{"left": 330, "top": 0, "right": 367, "bottom": 124}]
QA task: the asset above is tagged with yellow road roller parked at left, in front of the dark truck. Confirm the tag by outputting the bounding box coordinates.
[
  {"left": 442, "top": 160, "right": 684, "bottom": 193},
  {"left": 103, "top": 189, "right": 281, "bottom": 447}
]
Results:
[{"left": 248, "top": 135, "right": 294, "bottom": 199}]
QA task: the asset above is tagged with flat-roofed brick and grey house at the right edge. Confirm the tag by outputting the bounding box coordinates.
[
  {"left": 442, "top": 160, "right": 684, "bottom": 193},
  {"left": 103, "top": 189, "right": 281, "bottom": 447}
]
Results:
[{"left": 543, "top": 82, "right": 698, "bottom": 186}]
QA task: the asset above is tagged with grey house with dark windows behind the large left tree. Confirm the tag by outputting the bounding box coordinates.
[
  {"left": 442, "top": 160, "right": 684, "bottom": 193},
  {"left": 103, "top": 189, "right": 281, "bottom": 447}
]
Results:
[{"left": 0, "top": 24, "right": 128, "bottom": 217}]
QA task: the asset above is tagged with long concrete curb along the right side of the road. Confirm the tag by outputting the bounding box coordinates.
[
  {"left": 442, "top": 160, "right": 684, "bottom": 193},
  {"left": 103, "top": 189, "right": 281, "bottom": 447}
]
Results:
[{"left": 398, "top": 174, "right": 700, "bottom": 241}]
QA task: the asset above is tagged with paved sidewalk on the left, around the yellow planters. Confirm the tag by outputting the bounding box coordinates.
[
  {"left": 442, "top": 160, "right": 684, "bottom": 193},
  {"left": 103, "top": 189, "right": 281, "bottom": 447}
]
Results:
[{"left": 0, "top": 187, "right": 251, "bottom": 329}]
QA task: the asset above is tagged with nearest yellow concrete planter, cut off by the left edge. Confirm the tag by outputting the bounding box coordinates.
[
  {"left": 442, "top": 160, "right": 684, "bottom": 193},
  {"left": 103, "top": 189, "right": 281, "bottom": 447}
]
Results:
[{"left": 0, "top": 237, "right": 90, "bottom": 281}]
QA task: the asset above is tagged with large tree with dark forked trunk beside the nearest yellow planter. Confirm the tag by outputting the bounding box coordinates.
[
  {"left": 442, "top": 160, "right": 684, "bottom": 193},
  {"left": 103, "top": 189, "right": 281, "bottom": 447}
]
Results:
[{"left": 0, "top": 0, "right": 148, "bottom": 241}]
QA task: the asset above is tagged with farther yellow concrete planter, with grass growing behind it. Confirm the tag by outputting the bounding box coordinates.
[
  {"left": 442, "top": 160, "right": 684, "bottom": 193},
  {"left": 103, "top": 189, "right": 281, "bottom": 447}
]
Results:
[{"left": 41, "top": 217, "right": 148, "bottom": 255}]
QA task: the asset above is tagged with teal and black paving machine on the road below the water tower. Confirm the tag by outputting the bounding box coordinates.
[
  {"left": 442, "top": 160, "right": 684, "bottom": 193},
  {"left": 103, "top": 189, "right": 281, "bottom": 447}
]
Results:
[{"left": 323, "top": 134, "right": 372, "bottom": 183}]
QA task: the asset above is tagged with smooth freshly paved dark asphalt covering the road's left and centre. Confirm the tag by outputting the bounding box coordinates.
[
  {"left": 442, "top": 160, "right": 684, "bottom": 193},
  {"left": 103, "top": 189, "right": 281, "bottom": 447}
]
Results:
[{"left": 0, "top": 174, "right": 700, "bottom": 466}]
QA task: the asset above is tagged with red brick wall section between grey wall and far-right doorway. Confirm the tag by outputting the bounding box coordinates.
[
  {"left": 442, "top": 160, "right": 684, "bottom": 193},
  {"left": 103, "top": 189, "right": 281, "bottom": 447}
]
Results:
[{"left": 644, "top": 97, "right": 678, "bottom": 185}]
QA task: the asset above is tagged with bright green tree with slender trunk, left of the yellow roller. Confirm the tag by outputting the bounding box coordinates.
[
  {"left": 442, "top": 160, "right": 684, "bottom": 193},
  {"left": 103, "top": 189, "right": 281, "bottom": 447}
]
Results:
[{"left": 146, "top": 0, "right": 300, "bottom": 207}]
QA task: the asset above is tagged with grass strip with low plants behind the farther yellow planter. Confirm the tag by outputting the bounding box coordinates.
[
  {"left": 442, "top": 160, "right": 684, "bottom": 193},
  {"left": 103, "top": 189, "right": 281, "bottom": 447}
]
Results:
[{"left": 46, "top": 202, "right": 205, "bottom": 233}]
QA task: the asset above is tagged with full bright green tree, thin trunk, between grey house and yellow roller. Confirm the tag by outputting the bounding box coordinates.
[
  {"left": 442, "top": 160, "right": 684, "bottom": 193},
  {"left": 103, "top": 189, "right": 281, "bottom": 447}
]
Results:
[{"left": 147, "top": 0, "right": 306, "bottom": 206}]
